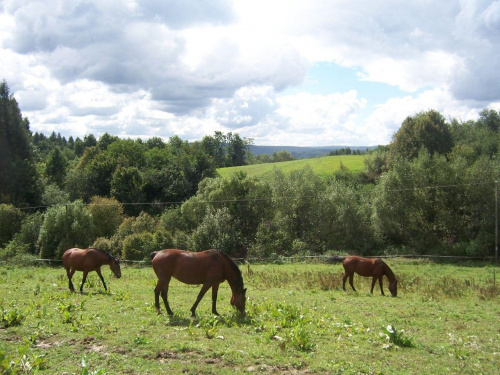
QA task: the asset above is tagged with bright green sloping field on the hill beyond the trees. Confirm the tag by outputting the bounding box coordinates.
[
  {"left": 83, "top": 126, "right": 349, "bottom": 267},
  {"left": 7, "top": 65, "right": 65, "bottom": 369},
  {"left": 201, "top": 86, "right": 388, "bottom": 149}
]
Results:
[{"left": 217, "top": 155, "right": 365, "bottom": 180}]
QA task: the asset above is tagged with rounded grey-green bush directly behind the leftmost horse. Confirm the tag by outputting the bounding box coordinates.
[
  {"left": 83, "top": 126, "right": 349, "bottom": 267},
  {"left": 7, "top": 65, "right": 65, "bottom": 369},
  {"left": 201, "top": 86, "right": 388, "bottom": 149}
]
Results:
[{"left": 38, "top": 202, "right": 96, "bottom": 259}]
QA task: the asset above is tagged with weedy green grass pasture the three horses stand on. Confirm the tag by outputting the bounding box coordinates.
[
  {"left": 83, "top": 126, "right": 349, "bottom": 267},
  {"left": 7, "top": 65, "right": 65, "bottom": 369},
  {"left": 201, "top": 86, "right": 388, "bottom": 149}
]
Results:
[{"left": 0, "top": 259, "right": 500, "bottom": 374}]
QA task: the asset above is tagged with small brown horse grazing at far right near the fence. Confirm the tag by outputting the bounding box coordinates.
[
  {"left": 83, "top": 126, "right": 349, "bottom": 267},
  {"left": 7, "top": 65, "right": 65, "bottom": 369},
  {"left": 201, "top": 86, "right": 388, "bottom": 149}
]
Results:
[{"left": 335, "top": 256, "right": 398, "bottom": 297}]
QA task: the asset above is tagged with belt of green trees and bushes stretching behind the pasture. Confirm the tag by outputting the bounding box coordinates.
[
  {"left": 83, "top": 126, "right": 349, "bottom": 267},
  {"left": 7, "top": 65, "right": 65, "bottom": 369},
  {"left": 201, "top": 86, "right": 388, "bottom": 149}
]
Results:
[{"left": 0, "top": 81, "right": 500, "bottom": 262}]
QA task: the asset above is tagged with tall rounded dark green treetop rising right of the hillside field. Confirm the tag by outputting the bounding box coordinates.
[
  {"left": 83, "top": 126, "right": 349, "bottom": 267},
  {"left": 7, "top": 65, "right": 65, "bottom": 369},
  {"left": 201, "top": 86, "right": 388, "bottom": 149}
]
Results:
[{"left": 389, "top": 110, "right": 453, "bottom": 166}]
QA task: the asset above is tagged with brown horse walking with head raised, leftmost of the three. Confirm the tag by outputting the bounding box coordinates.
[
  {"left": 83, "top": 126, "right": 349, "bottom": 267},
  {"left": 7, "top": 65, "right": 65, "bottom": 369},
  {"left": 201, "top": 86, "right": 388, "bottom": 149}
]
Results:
[{"left": 62, "top": 248, "right": 122, "bottom": 293}]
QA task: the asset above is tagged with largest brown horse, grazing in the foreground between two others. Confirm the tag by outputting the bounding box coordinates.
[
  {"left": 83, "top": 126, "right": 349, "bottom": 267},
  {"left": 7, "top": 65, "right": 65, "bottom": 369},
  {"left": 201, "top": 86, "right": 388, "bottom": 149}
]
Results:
[{"left": 151, "top": 249, "right": 246, "bottom": 316}]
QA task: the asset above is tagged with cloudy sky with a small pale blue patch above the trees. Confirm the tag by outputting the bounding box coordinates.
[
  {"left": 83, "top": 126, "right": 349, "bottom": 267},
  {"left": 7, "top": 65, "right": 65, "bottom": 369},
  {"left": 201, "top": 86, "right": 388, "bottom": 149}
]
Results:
[{"left": 0, "top": 0, "right": 500, "bottom": 146}]
